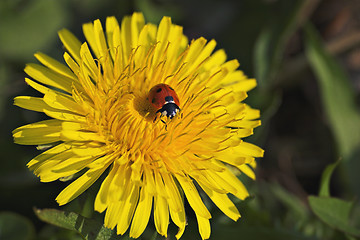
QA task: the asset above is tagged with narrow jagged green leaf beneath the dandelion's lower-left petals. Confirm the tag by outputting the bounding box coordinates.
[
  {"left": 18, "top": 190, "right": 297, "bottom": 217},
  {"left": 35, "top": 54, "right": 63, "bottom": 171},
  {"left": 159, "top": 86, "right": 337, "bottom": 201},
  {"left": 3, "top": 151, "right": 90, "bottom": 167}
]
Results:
[{"left": 34, "top": 209, "right": 124, "bottom": 240}]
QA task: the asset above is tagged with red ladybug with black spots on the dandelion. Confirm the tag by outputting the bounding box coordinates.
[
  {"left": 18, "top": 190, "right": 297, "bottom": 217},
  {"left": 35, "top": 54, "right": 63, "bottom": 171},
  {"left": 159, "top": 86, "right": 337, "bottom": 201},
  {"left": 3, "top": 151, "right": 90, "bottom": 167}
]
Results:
[{"left": 148, "top": 83, "right": 180, "bottom": 122}]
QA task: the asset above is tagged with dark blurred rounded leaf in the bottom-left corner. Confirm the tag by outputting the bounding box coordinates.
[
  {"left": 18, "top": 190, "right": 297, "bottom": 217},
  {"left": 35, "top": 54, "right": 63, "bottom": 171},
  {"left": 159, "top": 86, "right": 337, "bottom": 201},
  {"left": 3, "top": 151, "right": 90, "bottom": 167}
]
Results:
[{"left": 0, "top": 212, "right": 35, "bottom": 240}]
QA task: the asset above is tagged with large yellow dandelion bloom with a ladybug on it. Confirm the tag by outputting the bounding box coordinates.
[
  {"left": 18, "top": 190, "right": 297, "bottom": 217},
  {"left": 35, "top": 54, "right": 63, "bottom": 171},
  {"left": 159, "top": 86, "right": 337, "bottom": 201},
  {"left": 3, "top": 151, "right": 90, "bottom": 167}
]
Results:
[{"left": 13, "top": 13, "right": 263, "bottom": 239}]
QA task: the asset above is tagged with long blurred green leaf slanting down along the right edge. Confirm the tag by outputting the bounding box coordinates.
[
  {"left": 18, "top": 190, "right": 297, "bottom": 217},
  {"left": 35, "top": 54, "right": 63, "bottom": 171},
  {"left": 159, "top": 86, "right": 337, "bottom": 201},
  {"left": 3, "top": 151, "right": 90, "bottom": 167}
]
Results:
[{"left": 305, "top": 24, "right": 360, "bottom": 161}]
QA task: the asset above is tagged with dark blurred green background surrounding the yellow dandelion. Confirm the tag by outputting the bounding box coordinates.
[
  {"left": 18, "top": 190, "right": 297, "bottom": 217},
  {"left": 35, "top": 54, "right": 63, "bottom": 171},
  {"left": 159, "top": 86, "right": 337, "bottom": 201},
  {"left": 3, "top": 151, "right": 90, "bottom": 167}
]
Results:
[{"left": 0, "top": 0, "right": 360, "bottom": 240}]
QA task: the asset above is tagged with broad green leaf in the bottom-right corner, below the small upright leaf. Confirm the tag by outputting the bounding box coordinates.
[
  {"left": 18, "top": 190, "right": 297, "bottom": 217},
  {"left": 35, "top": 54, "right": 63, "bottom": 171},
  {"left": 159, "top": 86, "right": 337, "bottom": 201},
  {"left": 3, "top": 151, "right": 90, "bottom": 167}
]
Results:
[{"left": 308, "top": 196, "right": 360, "bottom": 237}]
